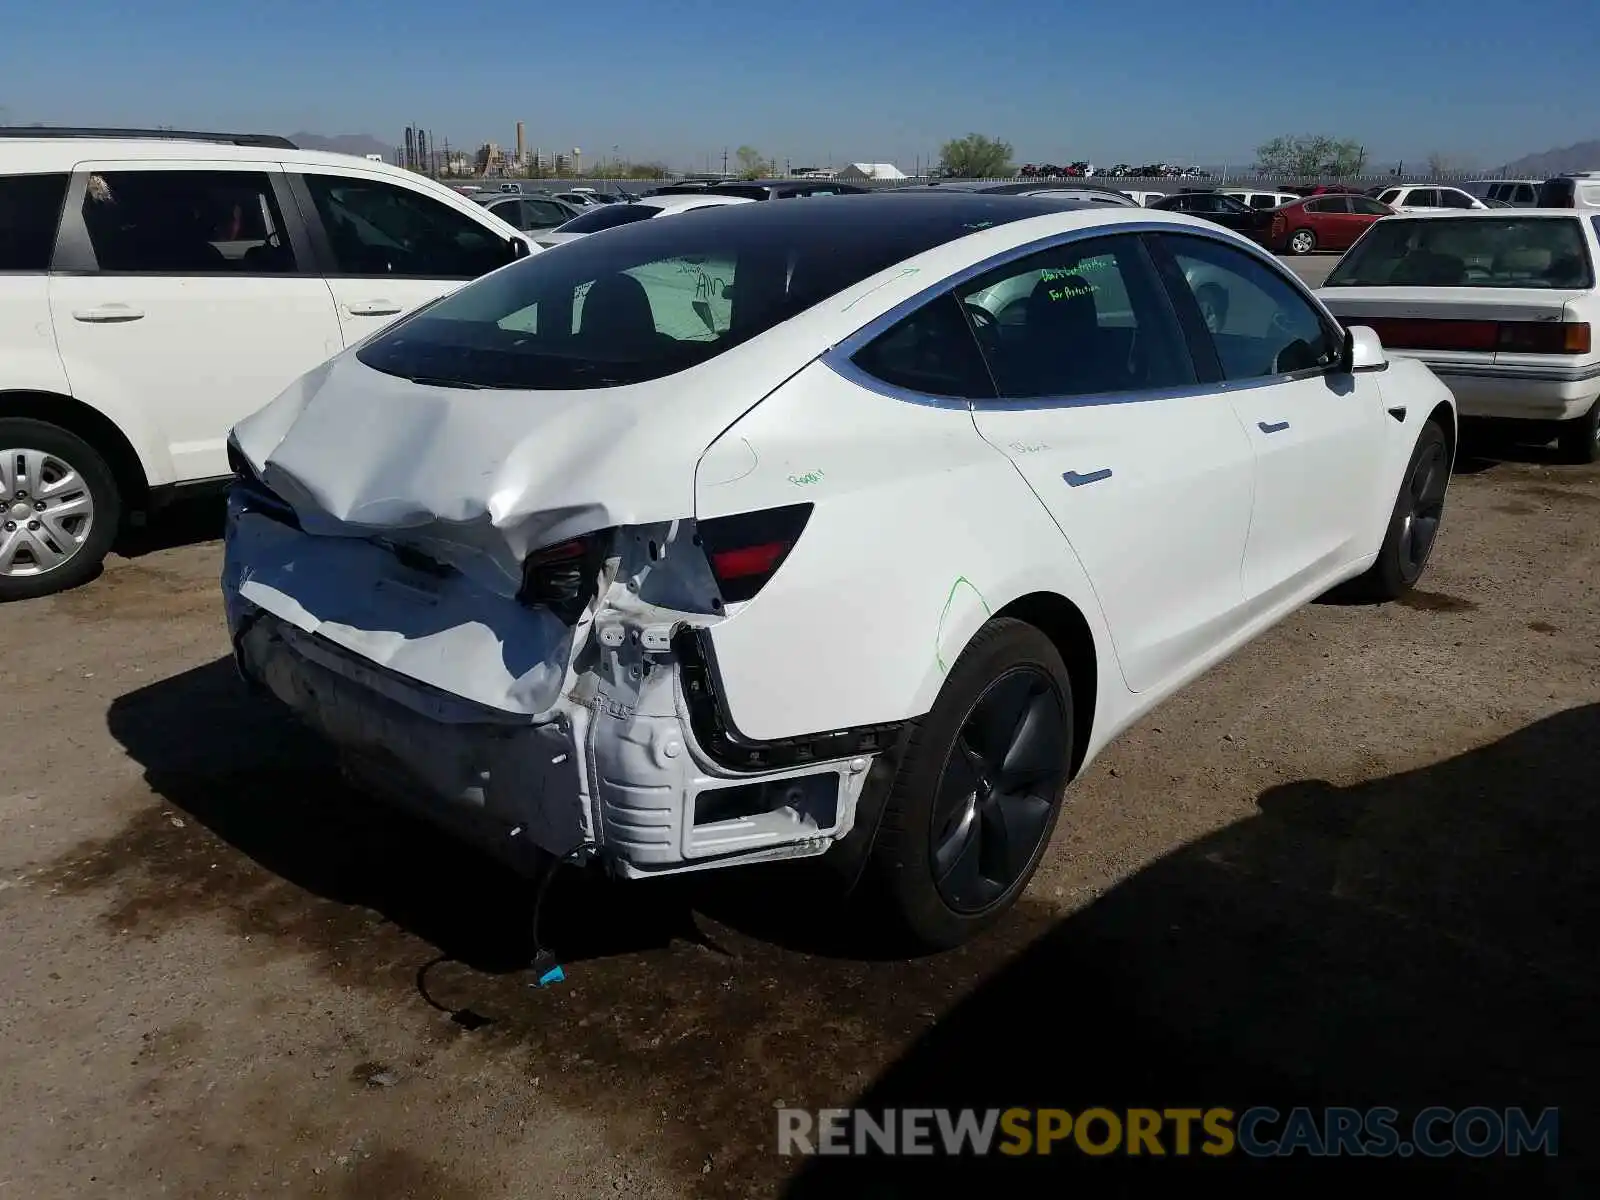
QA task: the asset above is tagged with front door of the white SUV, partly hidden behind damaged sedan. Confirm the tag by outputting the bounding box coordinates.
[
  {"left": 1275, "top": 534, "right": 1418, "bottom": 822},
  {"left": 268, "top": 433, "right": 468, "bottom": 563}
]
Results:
[{"left": 288, "top": 166, "right": 512, "bottom": 346}]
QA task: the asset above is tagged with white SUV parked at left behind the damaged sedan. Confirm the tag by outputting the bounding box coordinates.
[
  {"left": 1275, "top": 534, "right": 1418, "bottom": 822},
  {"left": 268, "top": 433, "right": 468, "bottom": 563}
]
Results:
[{"left": 0, "top": 130, "right": 539, "bottom": 600}]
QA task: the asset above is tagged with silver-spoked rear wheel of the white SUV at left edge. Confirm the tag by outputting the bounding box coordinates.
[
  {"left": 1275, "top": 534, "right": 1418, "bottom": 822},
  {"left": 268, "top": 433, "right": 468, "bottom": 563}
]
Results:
[{"left": 0, "top": 418, "right": 122, "bottom": 600}]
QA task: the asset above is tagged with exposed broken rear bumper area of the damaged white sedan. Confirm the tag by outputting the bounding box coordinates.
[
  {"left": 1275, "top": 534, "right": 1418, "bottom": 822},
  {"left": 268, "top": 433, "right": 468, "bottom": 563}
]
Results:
[{"left": 227, "top": 604, "right": 888, "bottom": 877}]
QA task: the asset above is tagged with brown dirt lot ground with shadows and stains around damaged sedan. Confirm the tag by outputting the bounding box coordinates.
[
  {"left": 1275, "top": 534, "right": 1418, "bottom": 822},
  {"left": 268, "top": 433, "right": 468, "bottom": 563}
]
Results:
[{"left": 0, "top": 428, "right": 1600, "bottom": 1200}]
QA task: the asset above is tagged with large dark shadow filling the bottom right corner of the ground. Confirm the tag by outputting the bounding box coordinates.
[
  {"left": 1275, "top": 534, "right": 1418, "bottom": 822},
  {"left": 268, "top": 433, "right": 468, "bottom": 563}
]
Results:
[{"left": 787, "top": 706, "right": 1600, "bottom": 1200}]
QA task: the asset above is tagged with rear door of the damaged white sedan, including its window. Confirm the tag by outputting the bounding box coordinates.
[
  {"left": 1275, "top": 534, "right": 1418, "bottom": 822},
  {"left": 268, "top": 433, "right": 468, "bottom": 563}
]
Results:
[{"left": 958, "top": 234, "right": 1253, "bottom": 691}]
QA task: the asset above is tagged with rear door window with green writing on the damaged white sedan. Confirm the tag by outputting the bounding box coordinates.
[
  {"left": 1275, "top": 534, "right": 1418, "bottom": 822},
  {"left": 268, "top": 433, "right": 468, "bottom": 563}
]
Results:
[{"left": 957, "top": 237, "right": 1195, "bottom": 398}]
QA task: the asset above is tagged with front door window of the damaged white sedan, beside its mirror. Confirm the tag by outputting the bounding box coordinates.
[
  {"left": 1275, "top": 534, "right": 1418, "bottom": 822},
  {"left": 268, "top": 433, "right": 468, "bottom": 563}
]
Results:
[{"left": 1162, "top": 234, "right": 1342, "bottom": 381}]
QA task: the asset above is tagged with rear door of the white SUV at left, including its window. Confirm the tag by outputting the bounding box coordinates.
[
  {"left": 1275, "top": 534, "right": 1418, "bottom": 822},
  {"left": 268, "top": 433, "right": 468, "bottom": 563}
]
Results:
[{"left": 50, "top": 160, "right": 342, "bottom": 482}]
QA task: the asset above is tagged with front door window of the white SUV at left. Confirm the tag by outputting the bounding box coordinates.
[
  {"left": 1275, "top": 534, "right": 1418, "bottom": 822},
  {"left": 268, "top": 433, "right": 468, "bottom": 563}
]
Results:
[{"left": 304, "top": 174, "right": 510, "bottom": 278}]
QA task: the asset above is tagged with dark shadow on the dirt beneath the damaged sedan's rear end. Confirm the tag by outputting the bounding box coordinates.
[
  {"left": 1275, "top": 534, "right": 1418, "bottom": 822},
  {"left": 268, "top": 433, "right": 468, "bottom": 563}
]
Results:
[{"left": 107, "top": 659, "right": 885, "bottom": 973}]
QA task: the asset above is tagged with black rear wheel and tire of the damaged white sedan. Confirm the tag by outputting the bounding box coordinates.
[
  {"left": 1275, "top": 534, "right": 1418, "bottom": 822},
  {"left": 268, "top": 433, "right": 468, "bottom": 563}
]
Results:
[{"left": 869, "top": 618, "right": 1072, "bottom": 950}]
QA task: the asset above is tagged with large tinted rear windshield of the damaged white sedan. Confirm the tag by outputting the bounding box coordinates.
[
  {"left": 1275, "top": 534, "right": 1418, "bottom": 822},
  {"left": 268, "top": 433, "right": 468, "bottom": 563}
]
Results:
[{"left": 357, "top": 195, "right": 1051, "bottom": 389}]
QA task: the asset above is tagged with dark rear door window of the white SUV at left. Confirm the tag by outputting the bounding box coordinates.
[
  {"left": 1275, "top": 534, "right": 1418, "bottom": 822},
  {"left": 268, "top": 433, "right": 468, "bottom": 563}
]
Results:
[{"left": 83, "top": 171, "right": 296, "bottom": 275}]
